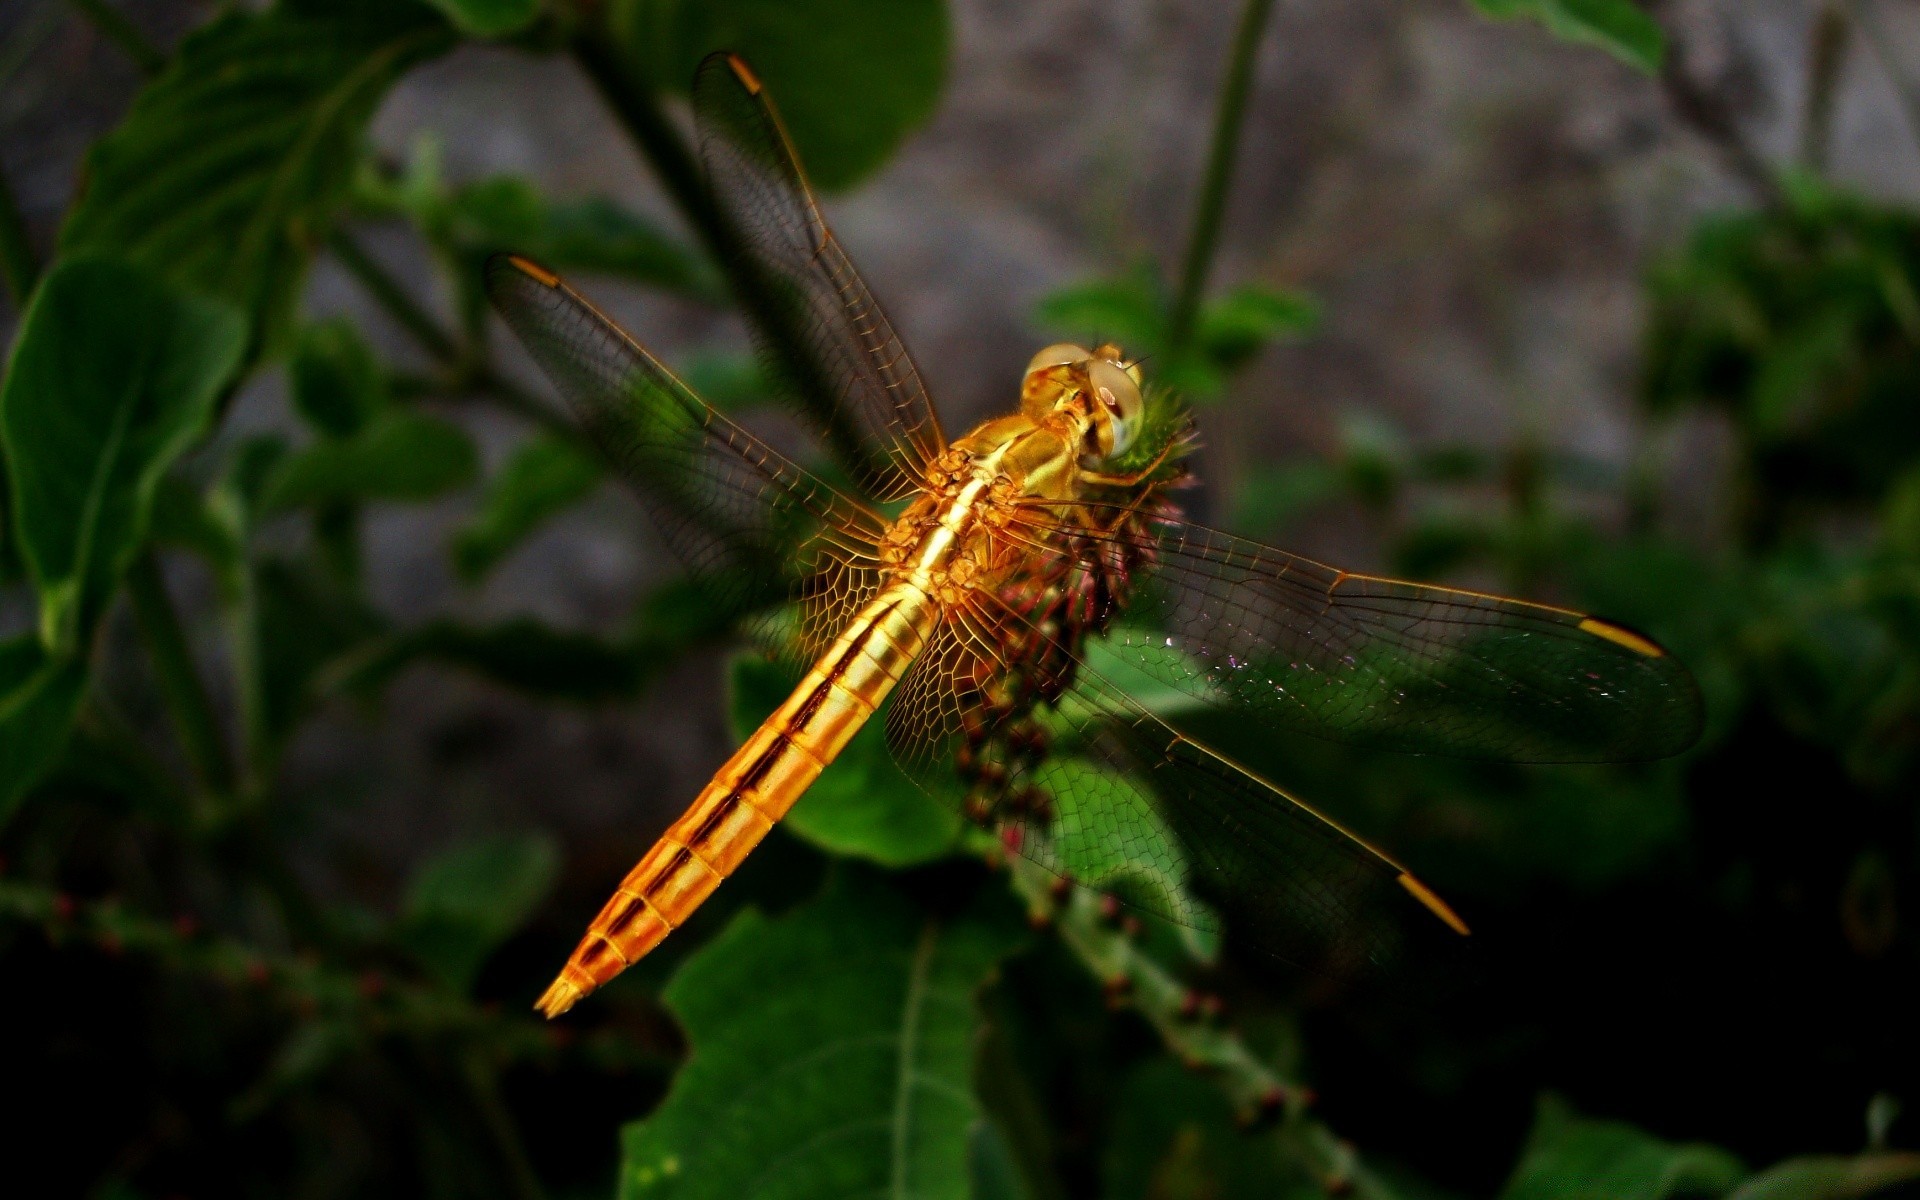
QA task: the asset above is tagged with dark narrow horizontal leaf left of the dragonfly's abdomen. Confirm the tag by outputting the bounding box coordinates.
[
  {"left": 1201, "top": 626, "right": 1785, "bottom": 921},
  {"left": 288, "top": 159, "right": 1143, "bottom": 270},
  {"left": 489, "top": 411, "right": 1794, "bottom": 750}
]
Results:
[{"left": 336, "top": 616, "right": 659, "bottom": 703}]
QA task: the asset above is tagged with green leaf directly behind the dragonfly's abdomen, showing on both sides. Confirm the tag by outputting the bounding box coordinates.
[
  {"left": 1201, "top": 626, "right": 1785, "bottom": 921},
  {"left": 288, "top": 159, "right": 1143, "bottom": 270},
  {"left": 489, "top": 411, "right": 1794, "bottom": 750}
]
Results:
[{"left": 728, "top": 653, "right": 962, "bottom": 868}]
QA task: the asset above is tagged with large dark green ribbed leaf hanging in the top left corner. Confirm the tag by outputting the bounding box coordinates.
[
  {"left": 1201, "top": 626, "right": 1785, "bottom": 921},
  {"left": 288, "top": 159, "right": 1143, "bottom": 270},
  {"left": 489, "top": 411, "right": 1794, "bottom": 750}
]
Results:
[{"left": 60, "top": 0, "right": 453, "bottom": 346}]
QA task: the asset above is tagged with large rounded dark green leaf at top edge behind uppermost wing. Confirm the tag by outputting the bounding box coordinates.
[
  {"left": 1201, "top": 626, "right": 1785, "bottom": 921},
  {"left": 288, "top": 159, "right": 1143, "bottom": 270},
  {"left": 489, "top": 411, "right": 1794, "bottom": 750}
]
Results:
[{"left": 614, "top": 0, "right": 948, "bottom": 192}]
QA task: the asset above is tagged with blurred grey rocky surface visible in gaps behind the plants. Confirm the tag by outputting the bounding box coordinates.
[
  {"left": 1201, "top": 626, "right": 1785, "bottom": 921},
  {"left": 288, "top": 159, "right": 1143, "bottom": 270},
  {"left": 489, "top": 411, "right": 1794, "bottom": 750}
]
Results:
[{"left": 0, "top": 0, "right": 1920, "bottom": 918}]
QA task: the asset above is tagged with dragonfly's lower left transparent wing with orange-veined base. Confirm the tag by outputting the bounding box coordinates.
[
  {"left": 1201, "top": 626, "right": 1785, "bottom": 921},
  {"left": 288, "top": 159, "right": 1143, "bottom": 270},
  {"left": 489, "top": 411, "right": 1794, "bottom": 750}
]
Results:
[{"left": 486, "top": 255, "right": 885, "bottom": 653}]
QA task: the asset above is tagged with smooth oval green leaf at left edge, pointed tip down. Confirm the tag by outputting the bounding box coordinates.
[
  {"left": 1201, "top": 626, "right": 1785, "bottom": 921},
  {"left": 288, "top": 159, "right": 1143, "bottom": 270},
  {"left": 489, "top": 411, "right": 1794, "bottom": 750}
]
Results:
[{"left": 0, "top": 259, "right": 246, "bottom": 657}]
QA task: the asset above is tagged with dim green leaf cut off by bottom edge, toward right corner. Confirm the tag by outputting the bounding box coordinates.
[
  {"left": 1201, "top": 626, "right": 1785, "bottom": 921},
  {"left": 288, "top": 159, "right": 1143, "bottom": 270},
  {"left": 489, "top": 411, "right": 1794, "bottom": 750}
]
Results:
[{"left": 1500, "top": 1096, "right": 1745, "bottom": 1200}]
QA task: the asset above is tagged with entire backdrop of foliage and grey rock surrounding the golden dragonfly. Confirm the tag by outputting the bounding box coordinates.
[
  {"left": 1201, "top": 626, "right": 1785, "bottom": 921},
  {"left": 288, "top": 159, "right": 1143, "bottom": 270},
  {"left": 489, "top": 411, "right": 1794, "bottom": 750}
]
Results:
[{"left": 0, "top": 0, "right": 1920, "bottom": 1200}]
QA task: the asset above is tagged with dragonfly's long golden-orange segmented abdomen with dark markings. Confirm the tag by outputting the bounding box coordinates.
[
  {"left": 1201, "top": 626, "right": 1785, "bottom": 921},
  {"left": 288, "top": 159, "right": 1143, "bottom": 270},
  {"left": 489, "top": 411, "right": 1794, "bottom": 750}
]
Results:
[{"left": 536, "top": 582, "right": 939, "bottom": 1018}]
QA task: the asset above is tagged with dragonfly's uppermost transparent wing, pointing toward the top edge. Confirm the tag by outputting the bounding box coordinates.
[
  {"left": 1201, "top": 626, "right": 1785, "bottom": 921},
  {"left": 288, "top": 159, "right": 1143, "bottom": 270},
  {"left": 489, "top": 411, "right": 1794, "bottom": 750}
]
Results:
[{"left": 693, "top": 54, "right": 947, "bottom": 501}]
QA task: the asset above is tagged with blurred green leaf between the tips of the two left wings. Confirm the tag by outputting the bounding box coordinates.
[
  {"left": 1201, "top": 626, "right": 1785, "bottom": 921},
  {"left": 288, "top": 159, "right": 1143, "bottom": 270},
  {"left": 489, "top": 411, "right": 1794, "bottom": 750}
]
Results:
[{"left": 445, "top": 175, "right": 726, "bottom": 301}]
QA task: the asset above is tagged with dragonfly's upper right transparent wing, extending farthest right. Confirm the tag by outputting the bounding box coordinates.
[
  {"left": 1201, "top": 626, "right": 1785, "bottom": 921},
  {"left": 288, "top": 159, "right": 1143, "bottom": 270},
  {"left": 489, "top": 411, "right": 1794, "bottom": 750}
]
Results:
[{"left": 1027, "top": 513, "right": 1701, "bottom": 762}]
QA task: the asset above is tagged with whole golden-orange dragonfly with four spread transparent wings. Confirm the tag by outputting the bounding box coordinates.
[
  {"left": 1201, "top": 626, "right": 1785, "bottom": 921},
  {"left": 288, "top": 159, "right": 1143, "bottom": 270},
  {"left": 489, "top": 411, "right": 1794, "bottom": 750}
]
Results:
[{"left": 486, "top": 54, "right": 1701, "bottom": 1018}]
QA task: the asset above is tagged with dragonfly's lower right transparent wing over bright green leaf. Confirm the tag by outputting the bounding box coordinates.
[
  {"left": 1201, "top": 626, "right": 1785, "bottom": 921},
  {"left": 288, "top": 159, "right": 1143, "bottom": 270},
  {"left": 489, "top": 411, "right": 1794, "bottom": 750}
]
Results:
[{"left": 887, "top": 583, "right": 1467, "bottom": 979}]
